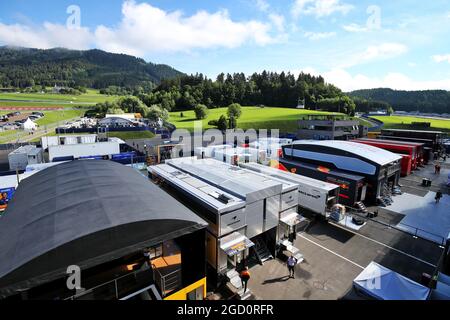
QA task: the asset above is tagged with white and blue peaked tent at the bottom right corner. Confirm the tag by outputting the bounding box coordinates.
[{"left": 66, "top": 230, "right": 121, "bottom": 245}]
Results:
[{"left": 353, "top": 261, "right": 430, "bottom": 300}]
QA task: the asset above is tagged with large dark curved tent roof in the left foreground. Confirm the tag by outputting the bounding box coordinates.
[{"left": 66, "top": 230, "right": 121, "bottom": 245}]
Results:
[{"left": 0, "top": 160, "right": 207, "bottom": 296}]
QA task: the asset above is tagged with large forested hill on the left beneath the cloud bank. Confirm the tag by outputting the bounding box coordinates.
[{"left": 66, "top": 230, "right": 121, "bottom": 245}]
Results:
[{"left": 0, "top": 47, "right": 182, "bottom": 89}]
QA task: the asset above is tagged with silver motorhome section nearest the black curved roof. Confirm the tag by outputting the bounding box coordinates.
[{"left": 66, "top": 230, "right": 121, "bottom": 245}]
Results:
[{"left": 147, "top": 164, "right": 248, "bottom": 281}]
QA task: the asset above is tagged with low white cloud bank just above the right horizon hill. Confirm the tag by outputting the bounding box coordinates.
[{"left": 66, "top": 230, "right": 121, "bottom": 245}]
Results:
[{"left": 322, "top": 69, "right": 450, "bottom": 92}]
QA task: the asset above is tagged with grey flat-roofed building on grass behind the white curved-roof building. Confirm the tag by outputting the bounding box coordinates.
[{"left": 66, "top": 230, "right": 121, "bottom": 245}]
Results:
[{"left": 297, "top": 116, "right": 367, "bottom": 140}]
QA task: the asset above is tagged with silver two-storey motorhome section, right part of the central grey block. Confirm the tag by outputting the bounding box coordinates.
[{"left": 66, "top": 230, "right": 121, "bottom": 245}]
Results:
[{"left": 166, "top": 157, "right": 301, "bottom": 276}]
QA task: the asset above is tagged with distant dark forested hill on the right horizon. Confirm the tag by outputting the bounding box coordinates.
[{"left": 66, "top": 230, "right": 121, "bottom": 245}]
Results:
[{"left": 349, "top": 88, "right": 450, "bottom": 113}]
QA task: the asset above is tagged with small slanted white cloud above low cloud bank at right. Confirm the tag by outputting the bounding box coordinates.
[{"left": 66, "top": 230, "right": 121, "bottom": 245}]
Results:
[{"left": 340, "top": 42, "right": 408, "bottom": 68}]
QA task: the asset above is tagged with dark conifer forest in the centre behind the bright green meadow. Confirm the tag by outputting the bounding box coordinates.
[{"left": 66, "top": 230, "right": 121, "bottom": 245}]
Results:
[{"left": 138, "top": 71, "right": 355, "bottom": 114}]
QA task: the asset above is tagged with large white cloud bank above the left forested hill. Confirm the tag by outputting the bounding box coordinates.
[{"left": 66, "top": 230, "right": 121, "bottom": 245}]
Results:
[{"left": 0, "top": 0, "right": 286, "bottom": 56}]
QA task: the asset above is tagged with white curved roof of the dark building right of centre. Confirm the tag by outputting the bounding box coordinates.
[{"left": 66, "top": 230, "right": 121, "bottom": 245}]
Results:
[{"left": 293, "top": 140, "right": 401, "bottom": 166}]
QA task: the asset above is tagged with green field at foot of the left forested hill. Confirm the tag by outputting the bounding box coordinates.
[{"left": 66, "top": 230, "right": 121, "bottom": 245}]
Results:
[{"left": 0, "top": 89, "right": 119, "bottom": 107}]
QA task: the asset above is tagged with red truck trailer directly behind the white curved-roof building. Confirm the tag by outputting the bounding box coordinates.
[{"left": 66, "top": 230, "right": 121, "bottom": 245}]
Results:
[{"left": 352, "top": 139, "right": 419, "bottom": 176}]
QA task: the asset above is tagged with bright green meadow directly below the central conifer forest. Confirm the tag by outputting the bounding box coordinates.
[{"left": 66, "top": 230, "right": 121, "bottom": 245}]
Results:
[{"left": 169, "top": 107, "right": 340, "bottom": 132}]
